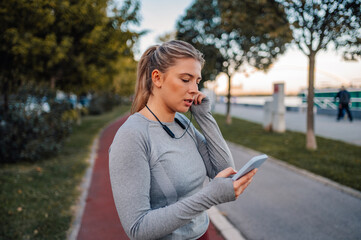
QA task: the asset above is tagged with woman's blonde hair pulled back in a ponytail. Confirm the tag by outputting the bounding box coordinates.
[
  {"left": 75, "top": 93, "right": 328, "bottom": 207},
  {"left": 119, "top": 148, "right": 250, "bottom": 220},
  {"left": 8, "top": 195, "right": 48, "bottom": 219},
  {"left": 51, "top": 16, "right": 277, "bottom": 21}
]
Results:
[{"left": 131, "top": 40, "right": 204, "bottom": 114}]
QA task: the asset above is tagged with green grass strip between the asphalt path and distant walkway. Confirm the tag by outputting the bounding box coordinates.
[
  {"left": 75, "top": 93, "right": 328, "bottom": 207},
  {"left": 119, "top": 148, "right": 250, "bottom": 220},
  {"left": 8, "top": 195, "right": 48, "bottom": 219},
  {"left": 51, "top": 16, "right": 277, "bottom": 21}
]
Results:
[{"left": 214, "top": 114, "right": 361, "bottom": 191}]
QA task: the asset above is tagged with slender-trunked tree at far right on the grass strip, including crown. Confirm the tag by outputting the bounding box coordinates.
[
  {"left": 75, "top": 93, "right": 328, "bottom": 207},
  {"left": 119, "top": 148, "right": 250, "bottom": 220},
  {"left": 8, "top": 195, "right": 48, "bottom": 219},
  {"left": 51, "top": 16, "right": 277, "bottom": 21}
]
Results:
[{"left": 280, "top": 0, "right": 361, "bottom": 150}]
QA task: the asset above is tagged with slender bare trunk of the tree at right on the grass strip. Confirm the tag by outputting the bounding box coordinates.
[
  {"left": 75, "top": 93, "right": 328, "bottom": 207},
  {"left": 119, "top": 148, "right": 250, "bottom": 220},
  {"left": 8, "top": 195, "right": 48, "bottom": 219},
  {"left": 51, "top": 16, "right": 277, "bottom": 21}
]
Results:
[{"left": 306, "top": 52, "right": 317, "bottom": 150}]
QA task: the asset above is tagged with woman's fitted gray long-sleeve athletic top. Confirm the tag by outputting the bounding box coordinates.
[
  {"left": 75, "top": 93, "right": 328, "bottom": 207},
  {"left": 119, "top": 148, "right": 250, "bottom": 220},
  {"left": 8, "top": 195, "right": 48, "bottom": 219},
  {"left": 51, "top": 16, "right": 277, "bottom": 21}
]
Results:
[{"left": 109, "top": 98, "right": 235, "bottom": 240}]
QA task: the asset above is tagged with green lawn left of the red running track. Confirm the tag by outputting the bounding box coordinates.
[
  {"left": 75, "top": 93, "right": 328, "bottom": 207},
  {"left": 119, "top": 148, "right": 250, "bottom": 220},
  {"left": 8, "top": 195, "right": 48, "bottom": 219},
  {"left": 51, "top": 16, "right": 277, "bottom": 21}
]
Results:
[{"left": 0, "top": 106, "right": 129, "bottom": 239}]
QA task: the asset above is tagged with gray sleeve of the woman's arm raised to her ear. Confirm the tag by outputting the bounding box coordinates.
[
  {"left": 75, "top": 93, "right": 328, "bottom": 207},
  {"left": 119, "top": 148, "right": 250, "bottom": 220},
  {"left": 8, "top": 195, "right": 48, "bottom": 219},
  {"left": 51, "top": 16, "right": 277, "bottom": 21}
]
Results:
[{"left": 191, "top": 97, "right": 235, "bottom": 178}]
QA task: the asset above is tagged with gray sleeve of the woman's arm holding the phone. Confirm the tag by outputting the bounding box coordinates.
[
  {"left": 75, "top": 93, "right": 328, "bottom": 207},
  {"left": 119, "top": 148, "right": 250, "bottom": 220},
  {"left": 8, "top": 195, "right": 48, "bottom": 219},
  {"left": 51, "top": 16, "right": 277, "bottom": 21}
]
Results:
[{"left": 109, "top": 126, "right": 235, "bottom": 239}]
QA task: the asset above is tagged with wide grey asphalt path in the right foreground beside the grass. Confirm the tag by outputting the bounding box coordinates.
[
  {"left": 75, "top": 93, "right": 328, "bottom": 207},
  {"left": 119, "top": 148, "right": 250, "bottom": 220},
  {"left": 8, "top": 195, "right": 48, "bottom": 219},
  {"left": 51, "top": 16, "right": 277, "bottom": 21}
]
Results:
[{"left": 217, "top": 143, "right": 361, "bottom": 240}]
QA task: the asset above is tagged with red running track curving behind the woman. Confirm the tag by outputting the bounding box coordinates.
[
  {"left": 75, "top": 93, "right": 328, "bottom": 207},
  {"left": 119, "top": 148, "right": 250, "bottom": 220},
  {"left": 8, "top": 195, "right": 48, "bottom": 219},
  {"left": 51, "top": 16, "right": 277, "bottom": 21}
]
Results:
[{"left": 73, "top": 114, "right": 223, "bottom": 240}]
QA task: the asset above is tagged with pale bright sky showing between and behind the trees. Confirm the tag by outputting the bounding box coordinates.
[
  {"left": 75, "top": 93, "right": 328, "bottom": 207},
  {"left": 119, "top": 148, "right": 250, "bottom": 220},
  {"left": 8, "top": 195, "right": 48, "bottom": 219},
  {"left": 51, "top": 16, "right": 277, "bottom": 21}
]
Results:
[{"left": 131, "top": 0, "right": 361, "bottom": 94}]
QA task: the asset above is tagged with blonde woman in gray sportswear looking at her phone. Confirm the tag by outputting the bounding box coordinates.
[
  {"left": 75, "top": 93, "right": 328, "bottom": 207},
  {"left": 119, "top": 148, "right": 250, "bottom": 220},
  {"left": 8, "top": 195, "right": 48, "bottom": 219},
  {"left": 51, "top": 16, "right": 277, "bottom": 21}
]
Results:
[{"left": 109, "top": 41, "right": 256, "bottom": 240}]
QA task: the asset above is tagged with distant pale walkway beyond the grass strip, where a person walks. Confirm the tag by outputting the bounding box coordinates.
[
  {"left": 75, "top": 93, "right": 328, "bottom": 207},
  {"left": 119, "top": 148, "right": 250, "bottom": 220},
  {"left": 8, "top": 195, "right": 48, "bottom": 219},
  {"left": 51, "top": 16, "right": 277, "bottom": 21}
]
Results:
[{"left": 214, "top": 103, "right": 361, "bottom": 146}]
